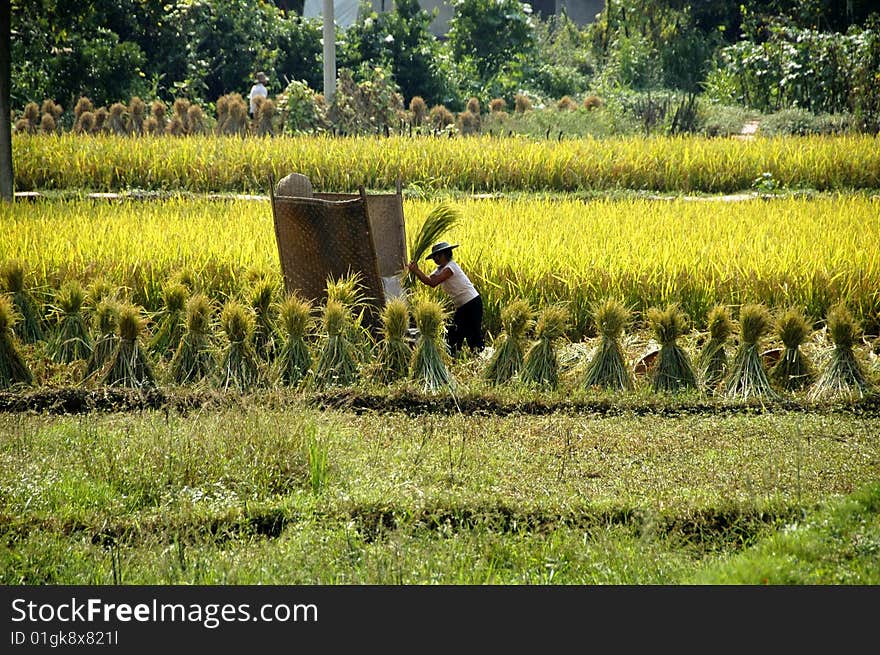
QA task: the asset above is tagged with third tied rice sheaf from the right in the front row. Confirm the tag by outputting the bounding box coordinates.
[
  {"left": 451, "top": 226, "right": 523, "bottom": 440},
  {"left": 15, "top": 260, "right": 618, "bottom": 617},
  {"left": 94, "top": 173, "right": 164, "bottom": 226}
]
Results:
[{"left": 725, "top": 304, "right": 777, "bottom": 400}]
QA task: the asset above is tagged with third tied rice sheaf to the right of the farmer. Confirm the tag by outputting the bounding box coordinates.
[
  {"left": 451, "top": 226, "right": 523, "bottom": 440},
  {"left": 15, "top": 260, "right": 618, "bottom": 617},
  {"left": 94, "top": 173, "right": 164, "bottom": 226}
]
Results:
[{"left": 584, "top": 298, "right": 635, "bottom": 391}]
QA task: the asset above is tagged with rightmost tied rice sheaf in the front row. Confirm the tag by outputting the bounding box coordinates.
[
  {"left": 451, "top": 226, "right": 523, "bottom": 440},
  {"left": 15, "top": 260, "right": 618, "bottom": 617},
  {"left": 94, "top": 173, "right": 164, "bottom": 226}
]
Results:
[{"left": 810, "top": 302, "right": 870, "bottom": 400}]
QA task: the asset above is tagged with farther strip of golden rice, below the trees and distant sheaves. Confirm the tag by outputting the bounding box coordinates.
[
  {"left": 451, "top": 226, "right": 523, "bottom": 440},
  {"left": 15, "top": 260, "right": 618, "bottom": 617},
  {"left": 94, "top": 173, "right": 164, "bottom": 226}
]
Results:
[{"left": 13, "top": 134, "right": 880, "bottom": 193}]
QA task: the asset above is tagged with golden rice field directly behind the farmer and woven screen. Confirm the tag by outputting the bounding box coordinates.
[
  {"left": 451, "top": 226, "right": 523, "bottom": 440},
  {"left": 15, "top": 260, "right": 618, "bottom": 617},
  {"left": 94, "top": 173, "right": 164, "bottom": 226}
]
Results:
[{"left": 0, "top": 195, "right": 880, "bottom": 337}]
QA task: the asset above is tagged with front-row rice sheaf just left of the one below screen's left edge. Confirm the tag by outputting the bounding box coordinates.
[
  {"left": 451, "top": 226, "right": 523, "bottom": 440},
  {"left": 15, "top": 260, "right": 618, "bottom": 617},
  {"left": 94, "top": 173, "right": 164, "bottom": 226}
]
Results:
[{"left": 217, "top": 298, "right": 262, "bottom": 392}]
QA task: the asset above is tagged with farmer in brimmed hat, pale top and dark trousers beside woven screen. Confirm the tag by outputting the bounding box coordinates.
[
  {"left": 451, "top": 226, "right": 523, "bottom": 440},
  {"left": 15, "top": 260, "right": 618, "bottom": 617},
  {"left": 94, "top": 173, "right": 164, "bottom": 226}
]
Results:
[{"left": 408, "top": 241, "right": 483, "bottom": 355}]
